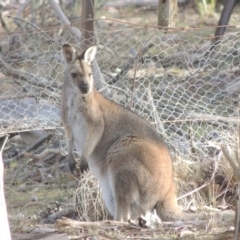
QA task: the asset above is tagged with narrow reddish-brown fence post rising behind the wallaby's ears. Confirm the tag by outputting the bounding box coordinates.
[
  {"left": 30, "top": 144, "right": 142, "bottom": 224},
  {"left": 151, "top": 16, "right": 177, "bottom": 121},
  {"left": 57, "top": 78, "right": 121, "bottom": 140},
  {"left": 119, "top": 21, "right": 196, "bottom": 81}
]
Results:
[{"left": 81, "top": 0, "right": 94, "bottom": 49}]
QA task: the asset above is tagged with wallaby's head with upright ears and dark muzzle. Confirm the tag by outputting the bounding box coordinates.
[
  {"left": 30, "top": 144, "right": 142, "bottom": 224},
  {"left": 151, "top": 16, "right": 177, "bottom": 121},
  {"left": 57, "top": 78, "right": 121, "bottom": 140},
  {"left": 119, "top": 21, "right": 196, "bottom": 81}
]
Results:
[{"left": 62, "top": 44, "right": 97, "bottom": 94}]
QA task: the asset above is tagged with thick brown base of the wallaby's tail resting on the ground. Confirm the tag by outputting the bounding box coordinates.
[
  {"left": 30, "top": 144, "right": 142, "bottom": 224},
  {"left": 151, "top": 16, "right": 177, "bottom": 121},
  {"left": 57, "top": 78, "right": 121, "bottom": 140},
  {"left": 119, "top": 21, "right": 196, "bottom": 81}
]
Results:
[{"left": 156, "top": 184, "right": 183, "bottom": 221}]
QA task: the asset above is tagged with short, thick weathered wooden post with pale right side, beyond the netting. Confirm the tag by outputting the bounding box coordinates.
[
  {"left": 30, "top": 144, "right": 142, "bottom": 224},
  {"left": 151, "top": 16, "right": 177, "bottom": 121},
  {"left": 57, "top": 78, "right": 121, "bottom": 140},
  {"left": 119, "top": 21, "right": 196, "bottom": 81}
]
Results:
[{"left": 158, "top": 0, "right": 178, "bottom": 32}]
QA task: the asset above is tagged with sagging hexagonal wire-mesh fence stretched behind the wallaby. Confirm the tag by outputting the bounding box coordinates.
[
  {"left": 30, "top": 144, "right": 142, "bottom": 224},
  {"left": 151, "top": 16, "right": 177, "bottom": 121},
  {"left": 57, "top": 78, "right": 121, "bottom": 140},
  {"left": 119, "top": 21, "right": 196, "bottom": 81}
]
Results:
[{"left": 0, "top": 20, "right": 240, "bottom": 163}]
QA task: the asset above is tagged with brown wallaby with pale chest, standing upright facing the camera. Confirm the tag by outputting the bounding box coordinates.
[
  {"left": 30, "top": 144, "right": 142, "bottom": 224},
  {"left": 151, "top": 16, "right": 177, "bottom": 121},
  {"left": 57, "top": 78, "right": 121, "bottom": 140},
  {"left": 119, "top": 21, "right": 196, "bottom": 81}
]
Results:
[{"left": 62, "top": 44, "right": 182, "bottom": 221}]
